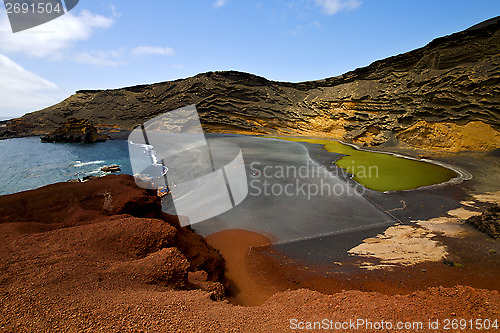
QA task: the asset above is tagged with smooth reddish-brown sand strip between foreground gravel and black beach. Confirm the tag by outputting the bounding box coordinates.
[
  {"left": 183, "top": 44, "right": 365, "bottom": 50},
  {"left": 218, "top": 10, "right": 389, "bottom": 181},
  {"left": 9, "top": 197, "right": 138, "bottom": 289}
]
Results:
[{"left": 207, "top": 227, "right": 500, "bottom": 306}]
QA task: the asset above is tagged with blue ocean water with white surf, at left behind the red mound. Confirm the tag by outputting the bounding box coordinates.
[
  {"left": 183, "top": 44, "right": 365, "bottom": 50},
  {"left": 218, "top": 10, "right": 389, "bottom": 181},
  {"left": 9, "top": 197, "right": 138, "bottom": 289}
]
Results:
[{"left": 0, "top": 137, "right": 132, "bottom": 195}]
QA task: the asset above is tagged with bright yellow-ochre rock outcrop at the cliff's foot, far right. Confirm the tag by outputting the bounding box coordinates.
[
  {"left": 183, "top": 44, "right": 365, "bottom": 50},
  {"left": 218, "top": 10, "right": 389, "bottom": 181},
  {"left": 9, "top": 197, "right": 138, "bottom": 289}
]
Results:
[{"left": 397, "top": 120, "right": 500, "bottom": 152}]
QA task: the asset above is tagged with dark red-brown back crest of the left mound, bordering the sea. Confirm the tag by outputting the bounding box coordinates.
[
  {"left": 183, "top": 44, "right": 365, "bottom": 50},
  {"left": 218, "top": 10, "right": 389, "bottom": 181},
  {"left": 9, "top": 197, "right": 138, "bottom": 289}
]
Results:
[{"left": 0, "top": 175, "right": 164, "bottom": 228}]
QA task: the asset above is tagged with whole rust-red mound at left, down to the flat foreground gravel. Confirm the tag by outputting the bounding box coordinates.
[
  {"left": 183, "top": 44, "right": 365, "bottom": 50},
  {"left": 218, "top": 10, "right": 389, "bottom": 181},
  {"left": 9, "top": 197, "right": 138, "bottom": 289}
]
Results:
[{"left": 0, "top": 175, "right": 225, "bottom": 290}]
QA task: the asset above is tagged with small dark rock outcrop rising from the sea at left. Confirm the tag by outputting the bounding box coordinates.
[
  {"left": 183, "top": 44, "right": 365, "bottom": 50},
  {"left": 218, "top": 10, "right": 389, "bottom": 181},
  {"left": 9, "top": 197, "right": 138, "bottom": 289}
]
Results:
[{"left": 40, "top": 118, "right": 109, "bottom": 143}]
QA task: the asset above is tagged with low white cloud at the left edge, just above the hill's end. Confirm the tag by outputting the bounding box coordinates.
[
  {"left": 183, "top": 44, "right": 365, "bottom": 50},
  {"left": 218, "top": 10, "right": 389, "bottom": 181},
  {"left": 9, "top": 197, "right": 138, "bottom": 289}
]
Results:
[{"left": 0, "top": 54, "right": 61, "bottom": 117}]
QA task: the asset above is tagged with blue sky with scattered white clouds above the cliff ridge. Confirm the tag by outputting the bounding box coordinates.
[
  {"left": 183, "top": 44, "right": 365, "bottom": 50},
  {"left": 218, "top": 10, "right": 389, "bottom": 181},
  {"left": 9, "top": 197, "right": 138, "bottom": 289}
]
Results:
[{"left": 0, "top": 0, "right": 500, "bottom": 119}]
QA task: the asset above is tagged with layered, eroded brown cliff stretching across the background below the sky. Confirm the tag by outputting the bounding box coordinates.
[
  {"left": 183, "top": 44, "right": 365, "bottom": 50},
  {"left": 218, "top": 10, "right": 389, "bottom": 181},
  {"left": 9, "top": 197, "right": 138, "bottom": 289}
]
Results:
[{"left": 0, "top": 18, "right": 500, "bottom": 150}]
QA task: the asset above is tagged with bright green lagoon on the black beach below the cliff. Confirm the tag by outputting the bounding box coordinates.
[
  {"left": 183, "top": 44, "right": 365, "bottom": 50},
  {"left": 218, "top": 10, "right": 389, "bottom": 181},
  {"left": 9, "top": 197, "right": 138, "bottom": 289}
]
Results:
[{"left": 275, "top": 137, "right": 457, "bottom": 192}]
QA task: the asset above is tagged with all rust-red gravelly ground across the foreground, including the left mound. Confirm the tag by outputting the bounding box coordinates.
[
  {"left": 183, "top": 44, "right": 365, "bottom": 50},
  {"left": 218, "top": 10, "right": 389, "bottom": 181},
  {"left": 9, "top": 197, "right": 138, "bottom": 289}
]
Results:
[{"left": 0, "top": 175, "right": 500, "bottom": 332}]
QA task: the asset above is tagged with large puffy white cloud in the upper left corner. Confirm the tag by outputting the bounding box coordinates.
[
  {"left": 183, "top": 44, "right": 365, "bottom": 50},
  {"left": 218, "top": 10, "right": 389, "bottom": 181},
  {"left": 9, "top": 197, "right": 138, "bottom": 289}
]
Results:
[{"left": 0, "top": 10, "right": 114, "bottom": 59}]
